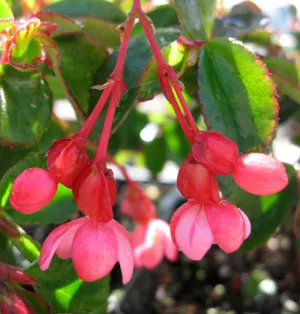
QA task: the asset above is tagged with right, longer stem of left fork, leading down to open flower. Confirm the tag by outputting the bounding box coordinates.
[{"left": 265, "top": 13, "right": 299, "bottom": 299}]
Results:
[{"left": 94, "top": 81, "right": 122, "bottom": 163}]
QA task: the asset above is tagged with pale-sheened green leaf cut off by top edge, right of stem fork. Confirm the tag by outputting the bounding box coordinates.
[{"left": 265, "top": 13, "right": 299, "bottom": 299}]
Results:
[{"left": 174, "top": 0, "right": 216, "bottom": 40}]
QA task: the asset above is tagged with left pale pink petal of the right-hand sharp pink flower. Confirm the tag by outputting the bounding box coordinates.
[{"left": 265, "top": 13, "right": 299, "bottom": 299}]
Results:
[{"left": 171, "top": 201, "right": 214, "bottom": 260}]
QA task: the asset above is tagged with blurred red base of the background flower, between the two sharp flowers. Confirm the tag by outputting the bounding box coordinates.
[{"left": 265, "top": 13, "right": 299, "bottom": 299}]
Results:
[{"left": 120, "top": 183, "right": 156, "bottom": 223}]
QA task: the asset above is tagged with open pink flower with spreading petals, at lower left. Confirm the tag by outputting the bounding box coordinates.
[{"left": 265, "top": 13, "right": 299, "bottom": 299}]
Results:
[{"left": 39, "top": 217, "right": 134, "bottom": 284}]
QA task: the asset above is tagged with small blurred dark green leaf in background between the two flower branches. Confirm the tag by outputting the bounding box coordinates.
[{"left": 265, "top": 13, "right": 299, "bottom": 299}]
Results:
[{"left": 145, "top": 136, "right": 167, "bottom": 177}]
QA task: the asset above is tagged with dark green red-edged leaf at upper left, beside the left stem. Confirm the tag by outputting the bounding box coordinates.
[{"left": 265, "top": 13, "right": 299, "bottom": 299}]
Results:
[{"left": 54, "top": 33, "right": 108, "bottom": 112}]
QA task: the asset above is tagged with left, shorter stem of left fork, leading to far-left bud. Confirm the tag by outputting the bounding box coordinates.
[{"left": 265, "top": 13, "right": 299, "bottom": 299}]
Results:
[{"left": 77, "top": 84, "right": 113, "bottom": 139}]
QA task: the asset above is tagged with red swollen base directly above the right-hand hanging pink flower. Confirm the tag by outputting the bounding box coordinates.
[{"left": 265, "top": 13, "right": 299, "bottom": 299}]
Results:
[{"left": 177, "top": 154, "right": 220, "bottom": 202}]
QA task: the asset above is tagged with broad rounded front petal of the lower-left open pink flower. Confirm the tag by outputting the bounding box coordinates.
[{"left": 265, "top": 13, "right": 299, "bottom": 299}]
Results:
[{"left": 72, "top": 220, "right": 118, "bottom": 281}]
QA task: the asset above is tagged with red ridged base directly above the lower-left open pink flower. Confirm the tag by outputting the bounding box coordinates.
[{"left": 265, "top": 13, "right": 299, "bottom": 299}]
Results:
[{"left": 73, "top": 163, "right": 117, "bottom": 222}]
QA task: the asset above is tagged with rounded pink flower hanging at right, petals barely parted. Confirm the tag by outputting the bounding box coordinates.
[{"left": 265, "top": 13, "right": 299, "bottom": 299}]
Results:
[{"left": 171, "top": 200, "right": 251, "bottom": 260}]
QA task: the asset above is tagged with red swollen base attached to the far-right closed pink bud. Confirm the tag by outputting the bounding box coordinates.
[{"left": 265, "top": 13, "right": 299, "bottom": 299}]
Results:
[{"left": 193, "top": 131, "right": 239, "bottom": 175}]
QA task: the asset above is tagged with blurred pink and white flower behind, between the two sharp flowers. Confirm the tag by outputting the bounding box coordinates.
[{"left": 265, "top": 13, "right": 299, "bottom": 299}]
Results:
[{"left": 131, "top": 219, "right": 178, "bottom": 269}]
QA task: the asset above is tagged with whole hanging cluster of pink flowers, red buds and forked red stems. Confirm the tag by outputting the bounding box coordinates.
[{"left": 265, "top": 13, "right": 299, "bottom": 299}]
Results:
[{"left": 10, "top": 0, "right": 288, "bottom": 284}]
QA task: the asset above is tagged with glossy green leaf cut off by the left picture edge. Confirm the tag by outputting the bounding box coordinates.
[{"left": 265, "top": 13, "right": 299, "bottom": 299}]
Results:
[{"left": 0, "top": 66, "right": 52, "bottom": 145}]
